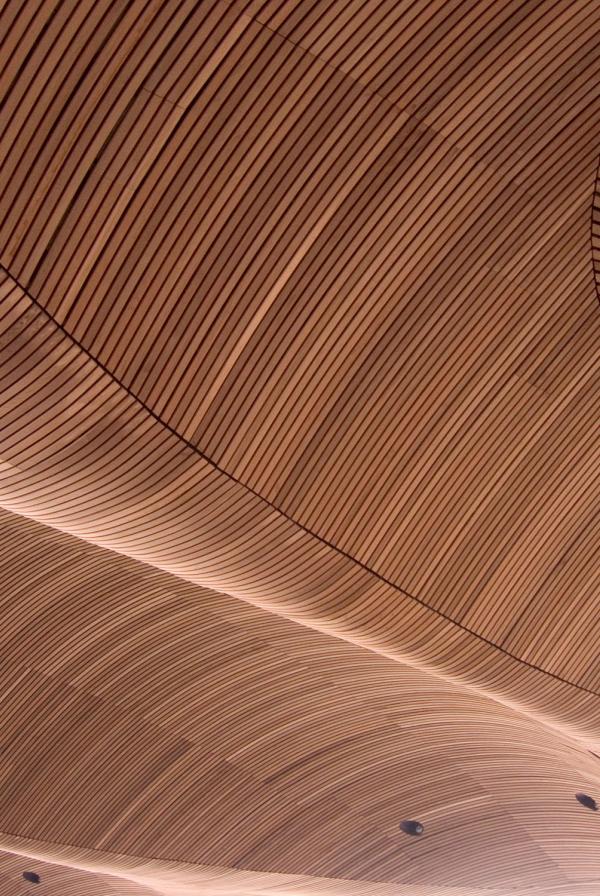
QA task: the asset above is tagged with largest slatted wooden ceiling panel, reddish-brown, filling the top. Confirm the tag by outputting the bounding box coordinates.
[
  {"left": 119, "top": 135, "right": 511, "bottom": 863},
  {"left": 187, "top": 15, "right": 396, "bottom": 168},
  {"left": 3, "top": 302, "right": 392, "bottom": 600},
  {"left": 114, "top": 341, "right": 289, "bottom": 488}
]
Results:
[{"left": 0, "top": 0, "right": 600, "bottom": 691}]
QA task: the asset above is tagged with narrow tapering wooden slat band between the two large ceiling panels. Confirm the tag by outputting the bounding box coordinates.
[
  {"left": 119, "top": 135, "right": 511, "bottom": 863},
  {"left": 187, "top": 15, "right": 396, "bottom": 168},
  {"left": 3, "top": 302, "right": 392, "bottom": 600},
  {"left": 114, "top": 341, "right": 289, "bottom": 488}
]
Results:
[{"left": 0, "top": 277, "right": 600, "bottom": 745}]
